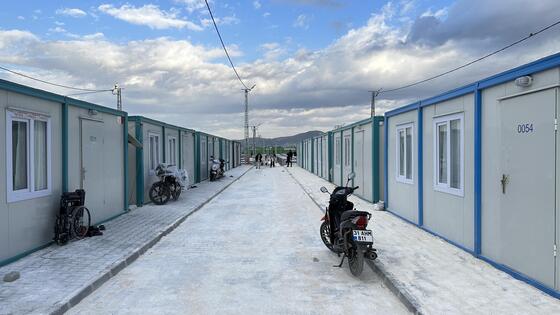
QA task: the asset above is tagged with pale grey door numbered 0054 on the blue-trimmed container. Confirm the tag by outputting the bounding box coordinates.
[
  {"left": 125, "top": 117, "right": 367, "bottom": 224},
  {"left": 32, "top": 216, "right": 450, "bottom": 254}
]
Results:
[{"left": 495, "top": 89, "right": 557, "bottom": 287}]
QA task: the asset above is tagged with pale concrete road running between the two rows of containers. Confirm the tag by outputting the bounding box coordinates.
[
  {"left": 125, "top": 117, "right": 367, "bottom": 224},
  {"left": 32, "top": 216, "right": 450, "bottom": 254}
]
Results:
[{"left": 69, "top": 167, "right": 407, "bottom": 314}]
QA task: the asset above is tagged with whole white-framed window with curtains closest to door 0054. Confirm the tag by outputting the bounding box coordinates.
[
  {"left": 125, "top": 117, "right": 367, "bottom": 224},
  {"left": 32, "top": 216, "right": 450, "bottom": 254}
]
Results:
[{"left": 434, "top": 113, "right": 464, "bottom": 196}]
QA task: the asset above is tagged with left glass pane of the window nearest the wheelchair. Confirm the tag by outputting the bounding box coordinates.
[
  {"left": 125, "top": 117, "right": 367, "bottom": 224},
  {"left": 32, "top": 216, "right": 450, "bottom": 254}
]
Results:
[{"left": 12, "top": 120, "right": 29, "bottom": 191}]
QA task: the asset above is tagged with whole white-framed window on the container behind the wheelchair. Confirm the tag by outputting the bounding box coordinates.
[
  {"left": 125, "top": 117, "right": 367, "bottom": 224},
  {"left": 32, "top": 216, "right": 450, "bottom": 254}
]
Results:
[{"left": 6, "top": 109, "right": 52, "bottom": 202}]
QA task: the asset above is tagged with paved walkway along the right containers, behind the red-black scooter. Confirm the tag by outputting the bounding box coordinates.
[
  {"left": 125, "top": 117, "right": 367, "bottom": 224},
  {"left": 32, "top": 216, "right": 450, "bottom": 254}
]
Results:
[{"left": 289, "top": 167, "right": 560, "bottom": 314}]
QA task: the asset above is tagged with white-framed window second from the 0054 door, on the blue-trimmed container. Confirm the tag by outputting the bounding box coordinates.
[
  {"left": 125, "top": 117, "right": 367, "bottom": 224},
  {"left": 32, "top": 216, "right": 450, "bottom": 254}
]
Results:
[{"left": 395, "top": 123, "right": 414, "bottom": 184}]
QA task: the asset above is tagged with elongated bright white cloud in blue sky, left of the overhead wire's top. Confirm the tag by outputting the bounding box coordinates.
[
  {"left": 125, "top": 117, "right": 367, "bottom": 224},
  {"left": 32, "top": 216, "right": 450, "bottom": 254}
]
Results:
[{"left": 98, "top": 4, "right": 202, "bottom": 31}]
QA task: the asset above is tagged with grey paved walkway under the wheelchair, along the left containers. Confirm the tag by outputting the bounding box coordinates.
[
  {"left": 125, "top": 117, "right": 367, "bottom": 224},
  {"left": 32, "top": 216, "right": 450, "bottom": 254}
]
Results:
[{"left": 0, "top": 166, "right": 249, "bottom": 314}]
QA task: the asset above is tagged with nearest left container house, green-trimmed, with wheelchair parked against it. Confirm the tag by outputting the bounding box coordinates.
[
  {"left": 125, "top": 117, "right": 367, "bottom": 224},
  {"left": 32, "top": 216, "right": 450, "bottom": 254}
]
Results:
[{"left": 0, "top": 80, "right": 128, "bottom": 265}]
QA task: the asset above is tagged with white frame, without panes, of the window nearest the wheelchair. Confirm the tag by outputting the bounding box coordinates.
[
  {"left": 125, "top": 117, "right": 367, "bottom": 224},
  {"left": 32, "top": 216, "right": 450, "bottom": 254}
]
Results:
[{"left": 6, "top": 108, "right": 52, "bottom": 203}]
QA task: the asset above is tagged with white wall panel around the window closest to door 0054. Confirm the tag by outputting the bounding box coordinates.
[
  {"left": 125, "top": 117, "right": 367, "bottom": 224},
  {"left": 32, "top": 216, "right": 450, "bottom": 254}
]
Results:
[{"left": 422, "top": 94, "right": 474, "bottom": 250}]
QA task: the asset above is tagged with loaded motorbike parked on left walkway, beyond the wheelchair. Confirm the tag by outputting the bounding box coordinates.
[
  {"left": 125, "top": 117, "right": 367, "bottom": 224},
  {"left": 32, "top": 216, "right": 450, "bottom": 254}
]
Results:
[{"left": 149, "top": 163, "right": 188, "bottom": 205}]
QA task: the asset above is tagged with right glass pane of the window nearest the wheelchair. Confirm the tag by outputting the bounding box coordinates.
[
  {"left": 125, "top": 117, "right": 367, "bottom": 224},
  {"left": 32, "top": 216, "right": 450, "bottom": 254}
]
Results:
[{"left": 33, "top": 120, "right": 48, "bottom": 191}]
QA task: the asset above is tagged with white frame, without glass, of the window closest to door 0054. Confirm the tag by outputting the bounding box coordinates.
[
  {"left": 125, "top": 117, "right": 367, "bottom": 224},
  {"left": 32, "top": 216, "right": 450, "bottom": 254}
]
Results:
[{"left": 433, "top": 113, "right": 465, "bottom": 197}]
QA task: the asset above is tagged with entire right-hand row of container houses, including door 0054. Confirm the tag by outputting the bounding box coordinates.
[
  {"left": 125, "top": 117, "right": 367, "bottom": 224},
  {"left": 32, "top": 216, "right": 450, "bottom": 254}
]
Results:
[{"left": 298, "top": 54, "right": 560, "bottom": 298}]
